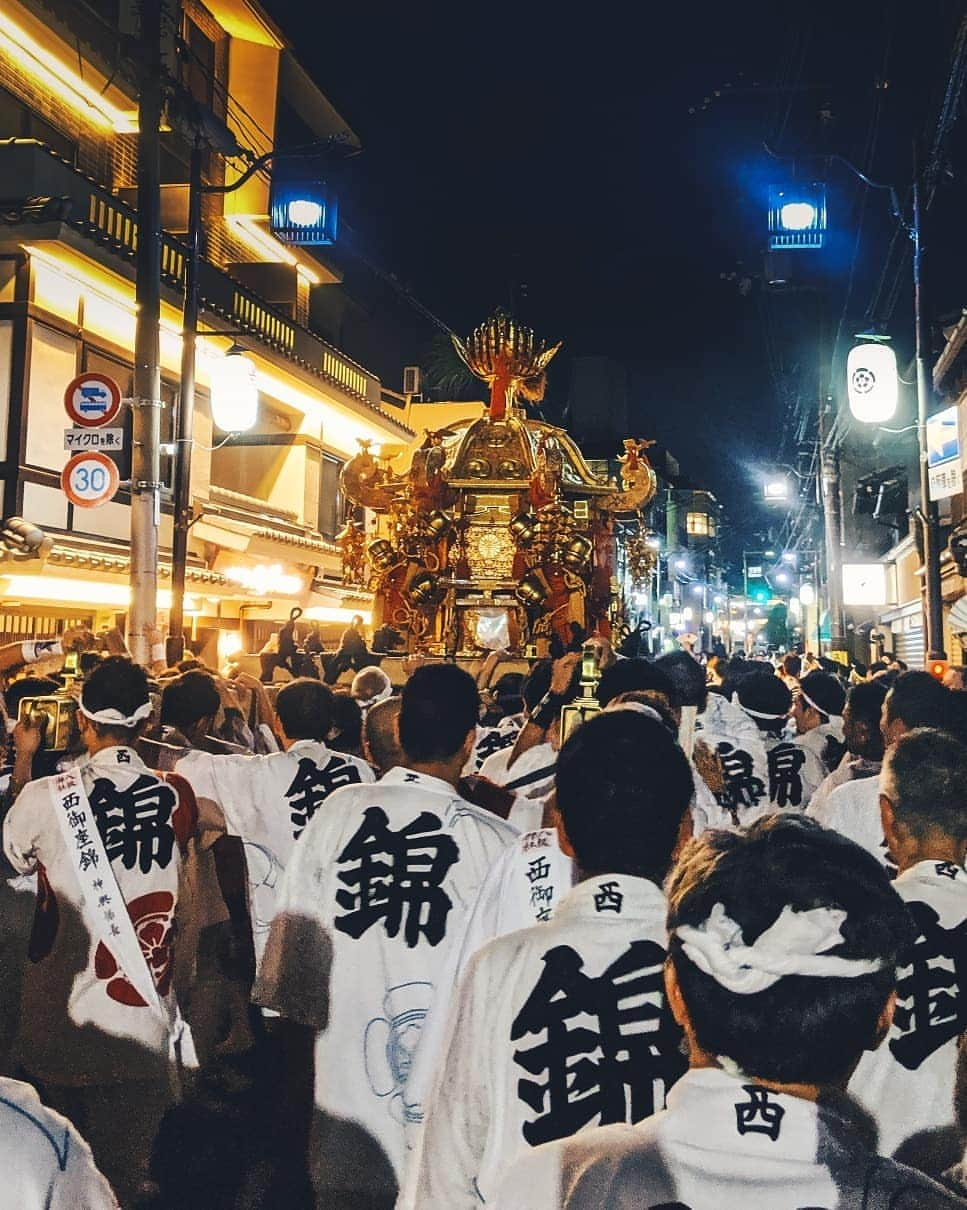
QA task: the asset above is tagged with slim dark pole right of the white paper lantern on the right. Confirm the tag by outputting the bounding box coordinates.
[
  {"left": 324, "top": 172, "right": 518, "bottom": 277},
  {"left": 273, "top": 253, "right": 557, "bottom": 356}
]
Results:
[{"left": 910, "top": 162, "right": 946, "bottom": 662}]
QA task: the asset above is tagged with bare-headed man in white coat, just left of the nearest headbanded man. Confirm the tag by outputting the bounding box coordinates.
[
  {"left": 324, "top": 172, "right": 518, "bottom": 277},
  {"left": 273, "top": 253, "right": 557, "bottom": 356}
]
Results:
[{"left": 413, "top": 709, "right": 693, "bottom": 1210}]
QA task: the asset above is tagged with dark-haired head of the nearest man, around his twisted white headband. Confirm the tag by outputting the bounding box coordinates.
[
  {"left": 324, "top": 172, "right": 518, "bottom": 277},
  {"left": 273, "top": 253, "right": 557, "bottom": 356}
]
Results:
[{"left": 666, "top": 814, "right": 915, "bottom": 1088}]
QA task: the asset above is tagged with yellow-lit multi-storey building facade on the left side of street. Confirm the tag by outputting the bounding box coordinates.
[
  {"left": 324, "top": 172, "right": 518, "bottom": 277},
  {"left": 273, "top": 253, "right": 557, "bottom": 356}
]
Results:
[{"left": 0, "top": 0, "right": 413, "bottom": 656}]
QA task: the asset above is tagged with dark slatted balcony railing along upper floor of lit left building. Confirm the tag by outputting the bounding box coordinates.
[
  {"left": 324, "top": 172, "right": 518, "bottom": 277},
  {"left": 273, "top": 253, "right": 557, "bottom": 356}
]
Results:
[{"left": 0, "top": 139, "right": 408, "bottom": 432}]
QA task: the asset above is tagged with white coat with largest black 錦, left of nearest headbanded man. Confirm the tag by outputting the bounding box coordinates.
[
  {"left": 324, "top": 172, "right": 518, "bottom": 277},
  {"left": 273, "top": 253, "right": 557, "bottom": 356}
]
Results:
[{"left": 413, "top": 875, "right": 685, "bottom": 1210}]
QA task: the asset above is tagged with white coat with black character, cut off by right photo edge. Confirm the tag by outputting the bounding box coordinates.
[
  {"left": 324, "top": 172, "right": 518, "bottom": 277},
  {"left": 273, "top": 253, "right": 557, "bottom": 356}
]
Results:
[{"left": 850, "top": 862, "right": 967, "bottom": 1156}]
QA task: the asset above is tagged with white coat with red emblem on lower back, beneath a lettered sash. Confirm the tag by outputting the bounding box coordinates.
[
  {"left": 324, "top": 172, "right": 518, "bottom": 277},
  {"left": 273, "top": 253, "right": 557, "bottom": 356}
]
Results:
[{"left": 4, "top": 747, "right": 197, "bottom": 1084}]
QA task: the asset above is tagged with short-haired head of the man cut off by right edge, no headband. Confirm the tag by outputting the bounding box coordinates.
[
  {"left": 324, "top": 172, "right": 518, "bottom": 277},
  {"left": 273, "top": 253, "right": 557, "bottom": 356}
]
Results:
[{"left": 880, "top": 727, "right": 967, "bottom": 869}]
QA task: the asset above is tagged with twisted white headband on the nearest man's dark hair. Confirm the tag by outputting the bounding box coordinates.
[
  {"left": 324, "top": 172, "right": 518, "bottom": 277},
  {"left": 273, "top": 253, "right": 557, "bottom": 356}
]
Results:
[{"left": 675, "top": 904, "right": 887, "bottom": 996}]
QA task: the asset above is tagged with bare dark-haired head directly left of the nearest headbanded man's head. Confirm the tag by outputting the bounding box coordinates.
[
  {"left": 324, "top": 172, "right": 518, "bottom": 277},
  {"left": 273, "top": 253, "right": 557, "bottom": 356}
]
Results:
[{"left": 554, "top": 709, "right": 695, "bottom": 883}]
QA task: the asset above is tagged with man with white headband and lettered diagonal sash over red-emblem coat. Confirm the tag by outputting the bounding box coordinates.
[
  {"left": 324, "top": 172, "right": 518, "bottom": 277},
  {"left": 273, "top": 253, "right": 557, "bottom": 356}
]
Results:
[{"left": 4, "top": 656, "right": 197, "bottom": 1206}]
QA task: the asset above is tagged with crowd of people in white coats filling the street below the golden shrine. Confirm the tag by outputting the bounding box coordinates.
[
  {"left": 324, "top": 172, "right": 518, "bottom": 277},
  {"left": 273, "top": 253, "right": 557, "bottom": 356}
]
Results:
[{"left": 0, "top": 620, "right": 967, "bottom": 1210}]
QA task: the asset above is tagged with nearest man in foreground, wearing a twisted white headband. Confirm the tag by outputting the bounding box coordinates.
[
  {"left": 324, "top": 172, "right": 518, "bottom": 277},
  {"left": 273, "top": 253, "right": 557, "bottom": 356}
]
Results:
[{"left": 496, "top": 813, "right": 963, "bottom": 1210}]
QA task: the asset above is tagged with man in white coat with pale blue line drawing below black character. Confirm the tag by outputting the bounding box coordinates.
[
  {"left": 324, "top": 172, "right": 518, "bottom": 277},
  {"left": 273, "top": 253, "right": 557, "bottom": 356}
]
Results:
[{"left": 254, "top": 664, "right": 516, "bottom": 1210}]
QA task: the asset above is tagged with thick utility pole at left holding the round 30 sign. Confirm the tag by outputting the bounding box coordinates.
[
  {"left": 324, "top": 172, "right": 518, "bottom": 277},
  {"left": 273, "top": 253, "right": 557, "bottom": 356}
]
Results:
[{"left": 127, "top": 0, "right": 163, "bottom": 664}]
